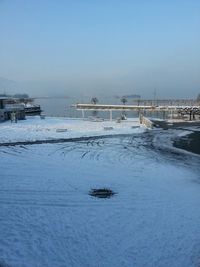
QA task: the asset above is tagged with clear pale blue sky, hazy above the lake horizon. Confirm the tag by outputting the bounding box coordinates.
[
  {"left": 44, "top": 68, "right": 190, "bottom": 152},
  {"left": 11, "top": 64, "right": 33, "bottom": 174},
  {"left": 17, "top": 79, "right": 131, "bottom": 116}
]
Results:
[{"left": 0, "top": 0, "right": 200, "bottom": 98}]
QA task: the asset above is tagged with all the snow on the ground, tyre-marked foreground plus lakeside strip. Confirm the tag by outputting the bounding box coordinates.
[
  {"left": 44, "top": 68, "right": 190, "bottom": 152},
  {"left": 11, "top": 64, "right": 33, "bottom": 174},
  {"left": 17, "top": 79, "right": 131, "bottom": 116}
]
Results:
[{"left": 0, "top": 118, "right": 200, "bottom": 267}]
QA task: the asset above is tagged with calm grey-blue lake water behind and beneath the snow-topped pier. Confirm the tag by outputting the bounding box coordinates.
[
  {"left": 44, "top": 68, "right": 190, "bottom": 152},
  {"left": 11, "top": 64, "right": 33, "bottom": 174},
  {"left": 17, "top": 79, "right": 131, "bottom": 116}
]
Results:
[{"left": 35, "top": 97, "right": 169, "bottom": 119}]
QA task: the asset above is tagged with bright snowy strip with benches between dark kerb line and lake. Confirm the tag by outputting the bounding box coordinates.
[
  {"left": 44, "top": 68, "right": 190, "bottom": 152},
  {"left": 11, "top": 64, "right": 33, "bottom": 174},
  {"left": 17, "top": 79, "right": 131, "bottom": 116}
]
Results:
[{"left": 0, "top": 116, "right": 144, "bottom": 143}]
